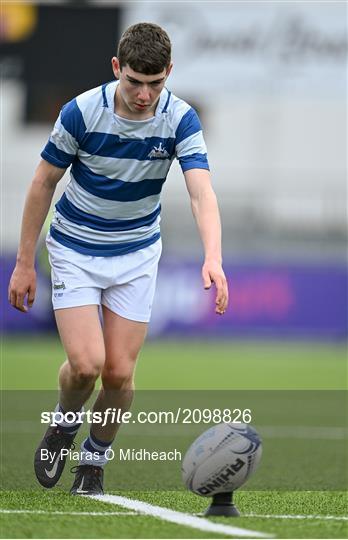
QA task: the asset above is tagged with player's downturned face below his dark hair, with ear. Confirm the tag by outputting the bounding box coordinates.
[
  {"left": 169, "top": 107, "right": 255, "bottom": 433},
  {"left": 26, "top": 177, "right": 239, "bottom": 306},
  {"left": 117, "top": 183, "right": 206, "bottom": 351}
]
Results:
[{"left": 112, "top": 57, "right": 172, "bottom": 119}]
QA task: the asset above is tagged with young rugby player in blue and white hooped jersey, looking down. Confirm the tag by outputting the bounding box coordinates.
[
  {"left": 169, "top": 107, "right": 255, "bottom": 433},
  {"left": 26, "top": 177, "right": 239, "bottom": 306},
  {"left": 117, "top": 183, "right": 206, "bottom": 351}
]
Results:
[{"left": 9, "top": 23, "right": 228, "bottom": 494}]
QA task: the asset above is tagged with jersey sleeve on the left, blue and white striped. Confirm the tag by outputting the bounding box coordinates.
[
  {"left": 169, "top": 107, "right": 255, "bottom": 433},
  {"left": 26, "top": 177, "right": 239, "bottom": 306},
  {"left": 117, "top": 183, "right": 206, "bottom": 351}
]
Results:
[{"left": 41, "top": 99, "right": 86, "bottom": 169}]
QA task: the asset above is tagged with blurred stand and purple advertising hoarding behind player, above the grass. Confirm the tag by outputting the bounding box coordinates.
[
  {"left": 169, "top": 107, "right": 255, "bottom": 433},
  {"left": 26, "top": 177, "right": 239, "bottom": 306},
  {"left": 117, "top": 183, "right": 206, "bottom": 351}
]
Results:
[{"left": 0, "top": 0, "right": 348, "bottom": 348}]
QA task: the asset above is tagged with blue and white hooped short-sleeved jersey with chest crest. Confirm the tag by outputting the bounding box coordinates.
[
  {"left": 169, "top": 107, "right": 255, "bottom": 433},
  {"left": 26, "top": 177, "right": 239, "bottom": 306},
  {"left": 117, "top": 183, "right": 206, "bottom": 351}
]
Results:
[{"left": 41, "top": 81, "right": 209, "bottom": 257}]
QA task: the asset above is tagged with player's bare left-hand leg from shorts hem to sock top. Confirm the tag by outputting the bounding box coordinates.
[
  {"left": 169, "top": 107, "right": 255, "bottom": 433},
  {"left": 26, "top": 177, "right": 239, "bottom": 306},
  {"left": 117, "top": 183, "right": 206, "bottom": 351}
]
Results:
[{"left": 55, "top": 305, "right": 105, "bottom": 411}]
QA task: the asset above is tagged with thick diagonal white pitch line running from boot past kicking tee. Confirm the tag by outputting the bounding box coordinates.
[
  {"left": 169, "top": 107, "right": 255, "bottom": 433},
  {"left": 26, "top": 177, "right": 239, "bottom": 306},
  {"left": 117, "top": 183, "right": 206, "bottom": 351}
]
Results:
[{"left": 91, "top": 495, "right": 273, "bottom": 538}]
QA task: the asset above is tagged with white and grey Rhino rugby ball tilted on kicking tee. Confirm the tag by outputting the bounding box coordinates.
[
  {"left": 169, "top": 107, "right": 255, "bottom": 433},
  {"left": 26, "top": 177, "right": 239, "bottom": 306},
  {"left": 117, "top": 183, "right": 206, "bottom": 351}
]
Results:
[{"left": 181, "top": 423, "right": 262, "bottom": 497}]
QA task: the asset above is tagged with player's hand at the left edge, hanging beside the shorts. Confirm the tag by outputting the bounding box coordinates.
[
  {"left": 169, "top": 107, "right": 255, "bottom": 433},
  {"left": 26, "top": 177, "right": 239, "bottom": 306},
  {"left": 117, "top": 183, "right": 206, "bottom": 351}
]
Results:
[{"left": 8, "top": 264, "right": 36, "bottom": 313}]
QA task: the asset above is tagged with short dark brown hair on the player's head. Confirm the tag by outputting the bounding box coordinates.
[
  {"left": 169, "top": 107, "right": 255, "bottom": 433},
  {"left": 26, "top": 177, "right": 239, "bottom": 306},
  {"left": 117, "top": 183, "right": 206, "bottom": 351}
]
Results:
[{"left": 117, "top": 23, "right": 172, "bottom": 75}]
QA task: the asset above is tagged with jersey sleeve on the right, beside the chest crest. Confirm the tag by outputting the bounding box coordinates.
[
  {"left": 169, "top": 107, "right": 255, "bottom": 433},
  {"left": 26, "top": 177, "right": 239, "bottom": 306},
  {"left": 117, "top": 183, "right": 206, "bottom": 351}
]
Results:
[{"left": 175, "top": 107, "right": 209, "bottom": 172}]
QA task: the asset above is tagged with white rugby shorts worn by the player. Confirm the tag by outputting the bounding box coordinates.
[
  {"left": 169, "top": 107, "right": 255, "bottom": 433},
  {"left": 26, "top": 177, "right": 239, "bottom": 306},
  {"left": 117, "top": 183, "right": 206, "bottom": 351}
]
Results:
[{"left": 46, "top": 233, "right": 162, "bottom": 322}]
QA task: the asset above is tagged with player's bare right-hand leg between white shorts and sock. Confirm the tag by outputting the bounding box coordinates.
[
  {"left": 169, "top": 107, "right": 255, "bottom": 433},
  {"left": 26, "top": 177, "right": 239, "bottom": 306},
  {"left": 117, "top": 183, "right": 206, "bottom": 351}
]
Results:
[{"left": 91, "top": 306, "right": 148, "bottom": 442}]
